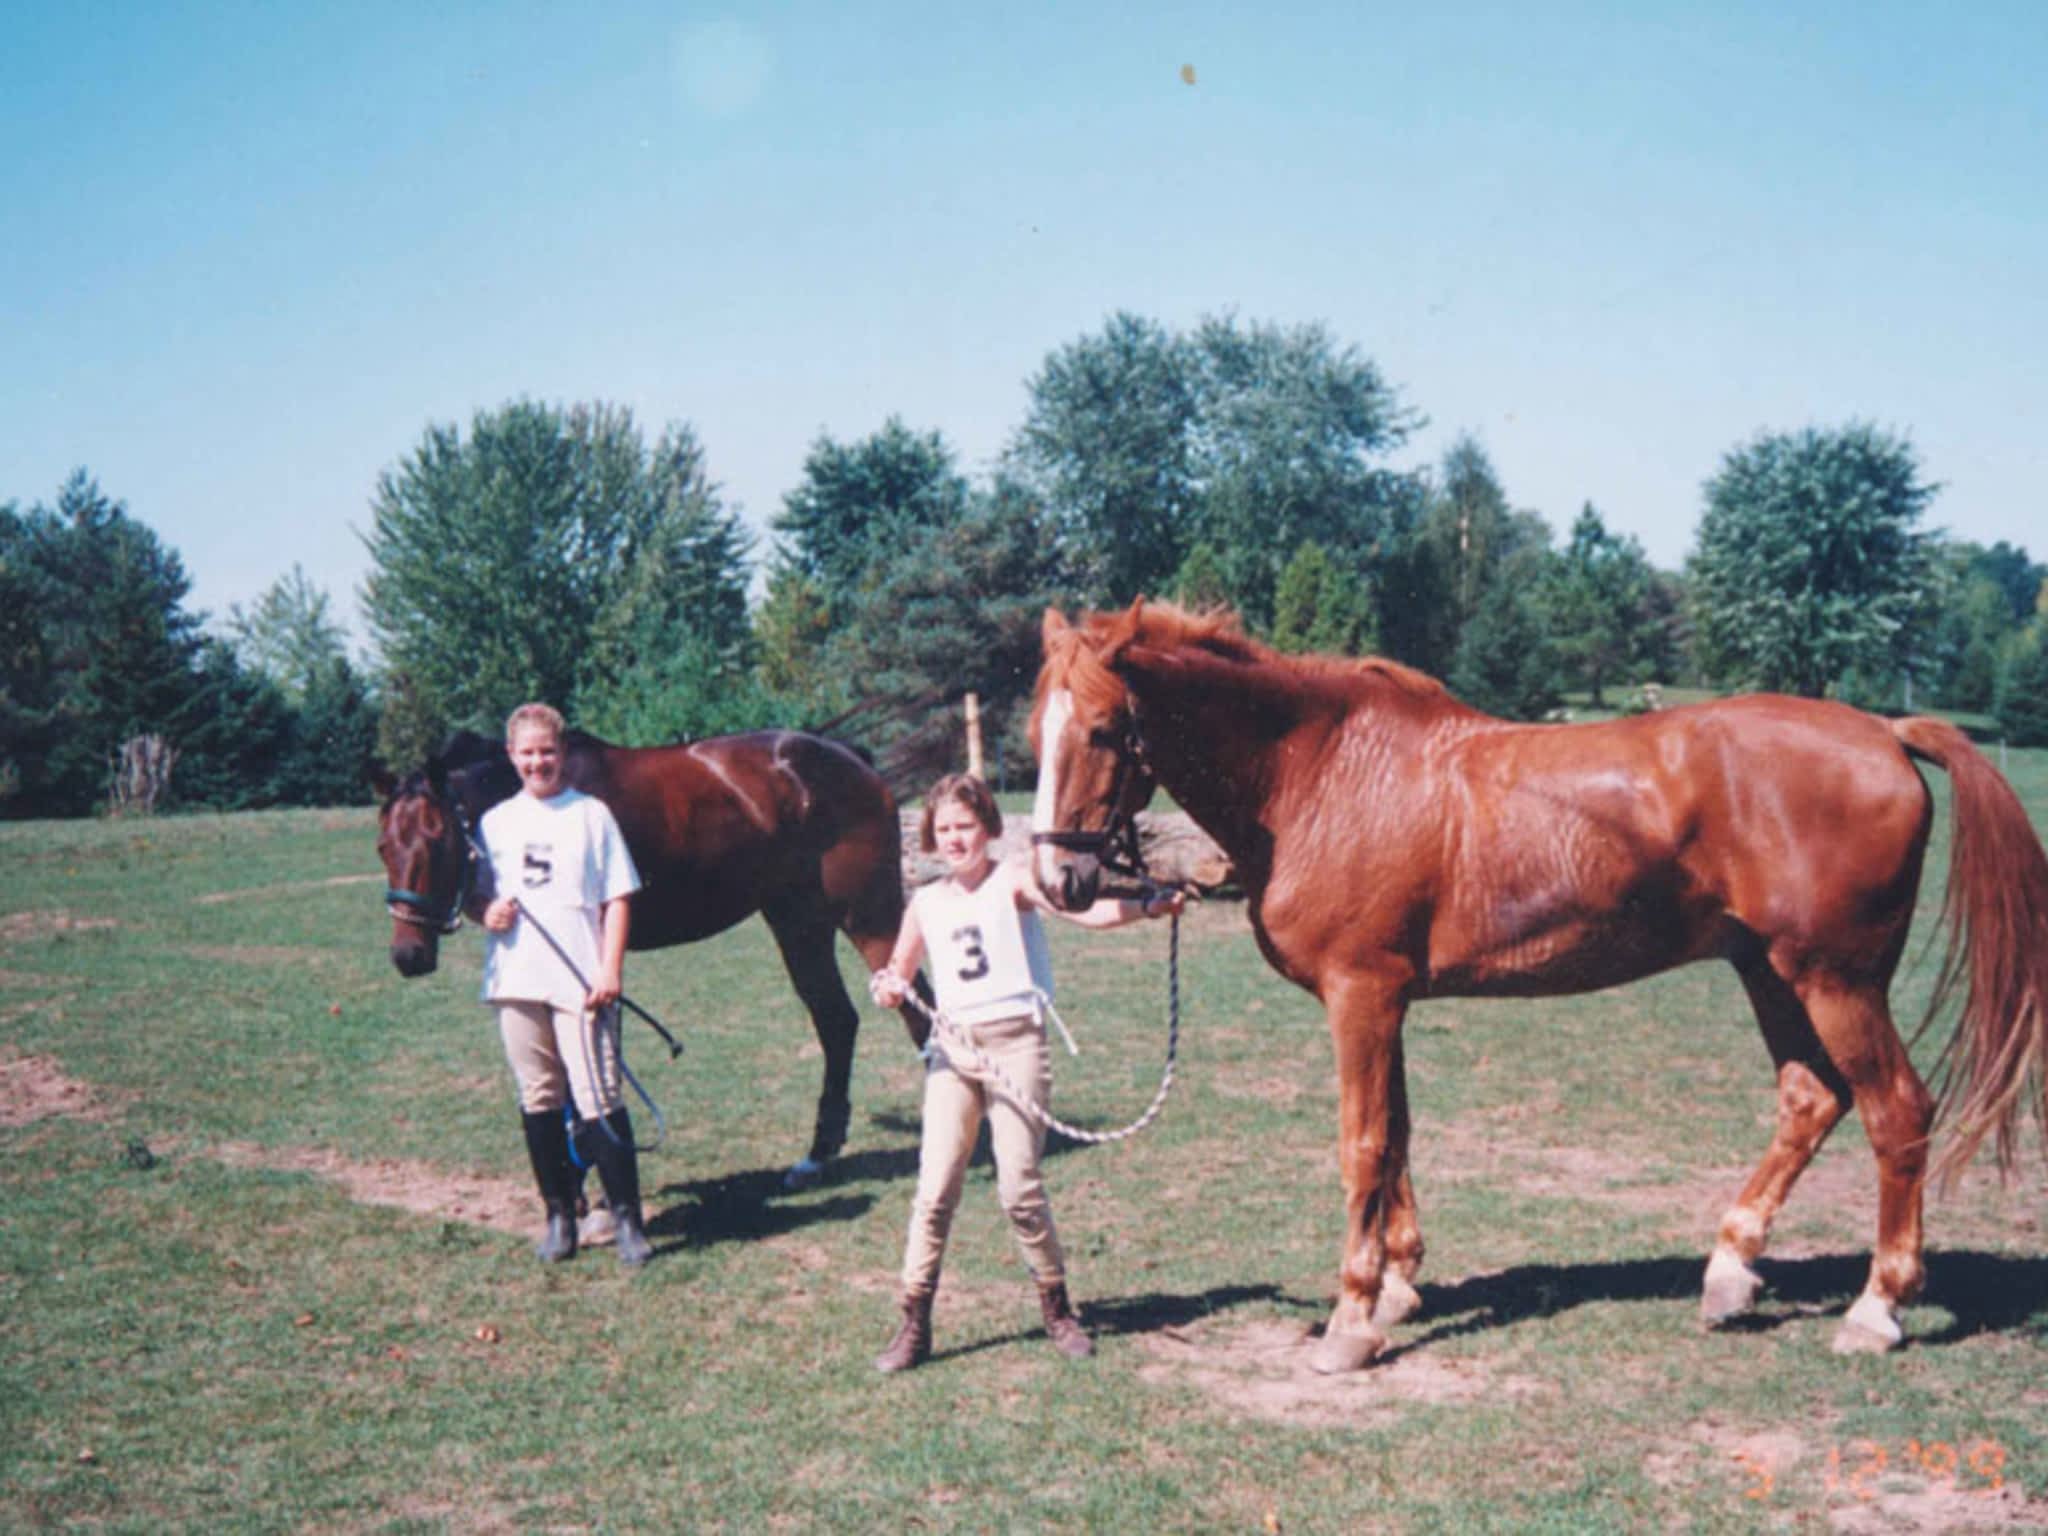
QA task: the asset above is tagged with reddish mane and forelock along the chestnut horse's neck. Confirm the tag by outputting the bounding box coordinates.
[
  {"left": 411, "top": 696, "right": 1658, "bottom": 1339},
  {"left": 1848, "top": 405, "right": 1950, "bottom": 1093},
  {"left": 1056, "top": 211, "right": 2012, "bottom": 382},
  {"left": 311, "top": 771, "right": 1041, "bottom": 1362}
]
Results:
[{"left": 1038, "top": 598, "right": 1450, "bottom": 713}]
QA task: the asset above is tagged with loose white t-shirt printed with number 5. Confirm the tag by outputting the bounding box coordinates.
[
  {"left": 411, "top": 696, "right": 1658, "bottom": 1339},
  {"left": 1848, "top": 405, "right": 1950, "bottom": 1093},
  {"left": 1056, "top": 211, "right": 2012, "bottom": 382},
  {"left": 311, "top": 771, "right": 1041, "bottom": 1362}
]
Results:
[{"left": 477, "top": 788, "right": 639, "bottom": 1010}]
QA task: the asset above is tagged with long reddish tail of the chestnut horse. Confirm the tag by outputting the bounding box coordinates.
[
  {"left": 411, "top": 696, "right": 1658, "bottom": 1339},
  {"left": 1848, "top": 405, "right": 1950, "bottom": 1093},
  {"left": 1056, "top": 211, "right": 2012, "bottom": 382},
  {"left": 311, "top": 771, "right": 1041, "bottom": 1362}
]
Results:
[{"left": 1890, "top": 719, "right": 2048, "bottom": 1182}]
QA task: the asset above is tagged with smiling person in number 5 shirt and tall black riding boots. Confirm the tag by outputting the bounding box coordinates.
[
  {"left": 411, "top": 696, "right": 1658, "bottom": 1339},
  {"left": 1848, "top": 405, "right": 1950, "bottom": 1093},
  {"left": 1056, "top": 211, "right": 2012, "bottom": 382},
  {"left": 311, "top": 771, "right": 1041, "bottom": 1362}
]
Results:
[{"left": 477, "top": 705, "right": 653, "bottom": 1268}]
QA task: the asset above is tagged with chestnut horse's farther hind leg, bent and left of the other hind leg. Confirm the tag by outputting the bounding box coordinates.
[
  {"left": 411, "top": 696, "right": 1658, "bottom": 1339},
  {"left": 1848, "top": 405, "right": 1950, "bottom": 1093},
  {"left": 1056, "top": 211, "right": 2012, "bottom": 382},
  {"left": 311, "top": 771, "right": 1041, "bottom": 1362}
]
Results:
[{"left": 1700, "top": 958, "right": 1849, "bottom": 1327}]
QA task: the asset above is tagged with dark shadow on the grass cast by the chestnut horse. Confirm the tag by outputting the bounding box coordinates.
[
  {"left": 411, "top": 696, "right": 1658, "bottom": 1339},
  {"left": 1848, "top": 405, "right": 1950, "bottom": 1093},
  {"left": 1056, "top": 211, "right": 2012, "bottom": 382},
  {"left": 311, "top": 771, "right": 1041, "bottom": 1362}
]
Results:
[{"left": 1384, "top": 1249, "right": 2048, "bottom": 1360}]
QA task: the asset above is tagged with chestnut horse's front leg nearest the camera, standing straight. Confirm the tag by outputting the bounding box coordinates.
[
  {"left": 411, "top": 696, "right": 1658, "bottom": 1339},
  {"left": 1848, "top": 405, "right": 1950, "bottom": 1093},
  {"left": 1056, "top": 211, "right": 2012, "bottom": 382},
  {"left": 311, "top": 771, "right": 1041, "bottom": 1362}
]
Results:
[{"left": 1309, "top": 977, "right": 1403, "bottom": 1374}]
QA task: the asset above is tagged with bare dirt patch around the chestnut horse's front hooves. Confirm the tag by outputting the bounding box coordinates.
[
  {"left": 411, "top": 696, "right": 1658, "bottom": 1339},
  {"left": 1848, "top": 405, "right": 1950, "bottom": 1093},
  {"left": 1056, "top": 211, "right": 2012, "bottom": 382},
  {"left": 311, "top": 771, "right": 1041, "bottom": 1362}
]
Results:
[{"left": 1139, "top": 1321, "right": 1544, "bottom": 1427}]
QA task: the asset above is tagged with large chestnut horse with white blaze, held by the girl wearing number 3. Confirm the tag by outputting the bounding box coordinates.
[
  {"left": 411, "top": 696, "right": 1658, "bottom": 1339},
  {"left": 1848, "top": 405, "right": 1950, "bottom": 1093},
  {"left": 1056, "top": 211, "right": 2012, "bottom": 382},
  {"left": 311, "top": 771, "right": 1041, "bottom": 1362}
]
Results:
[{"left": 1032, "top": 600, "right": 2048, "bottom": 1370}]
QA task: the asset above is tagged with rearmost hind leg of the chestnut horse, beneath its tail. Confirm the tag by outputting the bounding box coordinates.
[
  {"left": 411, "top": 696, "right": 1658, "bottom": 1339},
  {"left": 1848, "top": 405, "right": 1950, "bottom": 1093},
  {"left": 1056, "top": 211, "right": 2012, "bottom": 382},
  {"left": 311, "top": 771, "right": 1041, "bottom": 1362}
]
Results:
[{"left": 1798, "top": 973, "right": 1933, "bottom": 1354}]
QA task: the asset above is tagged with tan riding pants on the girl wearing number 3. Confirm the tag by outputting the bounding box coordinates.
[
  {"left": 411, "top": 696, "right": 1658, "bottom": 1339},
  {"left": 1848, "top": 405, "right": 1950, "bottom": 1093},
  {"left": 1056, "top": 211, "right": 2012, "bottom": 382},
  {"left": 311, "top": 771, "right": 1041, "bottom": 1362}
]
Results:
[{"left": 903, "top": 1016, "right": 1067, "bottom": 1290}]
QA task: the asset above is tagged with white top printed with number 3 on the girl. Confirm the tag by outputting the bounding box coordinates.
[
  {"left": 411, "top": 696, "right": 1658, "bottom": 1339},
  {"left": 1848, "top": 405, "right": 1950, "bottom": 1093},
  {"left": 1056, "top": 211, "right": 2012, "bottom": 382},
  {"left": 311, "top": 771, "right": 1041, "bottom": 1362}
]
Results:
[{"left": 911, "top": 864, "right": 1053, "bottom": 1024}]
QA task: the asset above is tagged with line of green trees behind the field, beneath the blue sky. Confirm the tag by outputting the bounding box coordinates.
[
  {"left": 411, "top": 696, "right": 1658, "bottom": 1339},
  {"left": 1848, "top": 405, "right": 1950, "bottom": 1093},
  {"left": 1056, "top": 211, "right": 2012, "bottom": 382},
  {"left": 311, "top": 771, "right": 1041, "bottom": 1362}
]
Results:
[{"left": 0, "top": 313, "right": 2048, "bottom": 817}]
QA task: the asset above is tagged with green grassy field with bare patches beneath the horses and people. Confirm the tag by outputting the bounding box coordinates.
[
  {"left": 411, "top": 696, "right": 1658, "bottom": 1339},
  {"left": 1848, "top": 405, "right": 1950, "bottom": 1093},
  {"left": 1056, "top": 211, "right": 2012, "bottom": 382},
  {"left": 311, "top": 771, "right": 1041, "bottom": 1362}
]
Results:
[{"left": 0, "top": 754, "right": 2048, "bottom": 1532}]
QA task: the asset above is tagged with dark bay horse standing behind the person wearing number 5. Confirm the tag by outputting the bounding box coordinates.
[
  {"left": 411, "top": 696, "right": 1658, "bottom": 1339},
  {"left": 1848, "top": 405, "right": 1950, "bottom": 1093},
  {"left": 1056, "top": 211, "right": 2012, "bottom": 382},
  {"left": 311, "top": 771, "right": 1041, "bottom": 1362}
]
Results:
[{"left": 377, "top": 731, "right": 926, "bottom": 1184}]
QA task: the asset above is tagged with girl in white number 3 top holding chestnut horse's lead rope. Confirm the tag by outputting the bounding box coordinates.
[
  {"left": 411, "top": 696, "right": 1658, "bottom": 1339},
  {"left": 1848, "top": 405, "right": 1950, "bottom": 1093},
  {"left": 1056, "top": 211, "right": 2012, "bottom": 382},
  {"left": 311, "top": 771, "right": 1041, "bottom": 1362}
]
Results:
[{"left": 872, "top": 774, "right": 1182, "bottom": 1370}]
